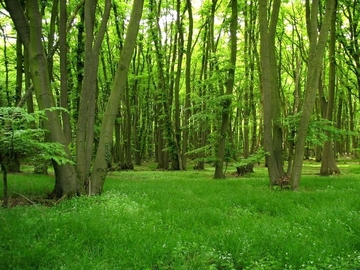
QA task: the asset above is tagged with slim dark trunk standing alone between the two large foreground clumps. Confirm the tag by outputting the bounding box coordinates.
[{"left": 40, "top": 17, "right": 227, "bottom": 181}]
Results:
[{"left": 214, "top": 0, "right": 238, "bottom": 179}]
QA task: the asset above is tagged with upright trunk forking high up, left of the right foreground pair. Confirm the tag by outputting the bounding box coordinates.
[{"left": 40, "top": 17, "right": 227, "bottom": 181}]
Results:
[{"left": 259, "top": 0, "right": 285, "bottom": 186}]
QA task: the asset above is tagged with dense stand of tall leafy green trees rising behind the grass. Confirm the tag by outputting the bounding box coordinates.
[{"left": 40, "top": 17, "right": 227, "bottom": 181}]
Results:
[{"left": 0, "top": 0, "right": 360, "bottom": 197}]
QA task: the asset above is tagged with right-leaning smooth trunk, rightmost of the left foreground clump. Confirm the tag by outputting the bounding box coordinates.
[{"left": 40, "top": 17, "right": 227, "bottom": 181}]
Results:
[{"left": 88, "top": 0, "right": 144, "bottom": 194}]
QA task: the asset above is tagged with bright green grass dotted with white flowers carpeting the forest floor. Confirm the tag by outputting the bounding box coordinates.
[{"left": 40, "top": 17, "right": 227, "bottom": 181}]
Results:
[{"left": 0, "top": 163, "right": 360, "bottom": 270}]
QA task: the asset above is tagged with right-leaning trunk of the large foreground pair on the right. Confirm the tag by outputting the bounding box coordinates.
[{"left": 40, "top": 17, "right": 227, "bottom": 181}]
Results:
[{"left": 290, "top": 0, "right": 335, "bottom": 190}]
